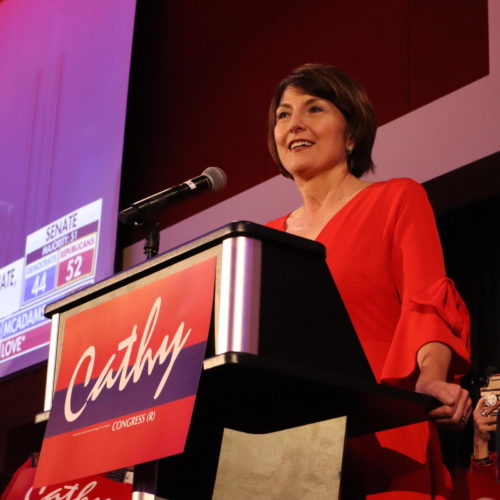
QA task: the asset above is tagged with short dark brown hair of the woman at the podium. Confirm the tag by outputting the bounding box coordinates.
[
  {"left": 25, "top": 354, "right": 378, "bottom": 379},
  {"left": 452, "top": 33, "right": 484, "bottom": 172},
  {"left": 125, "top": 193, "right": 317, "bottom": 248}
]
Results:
[{"left": 267, "top": 64, "right": 377, "bottom": 178}]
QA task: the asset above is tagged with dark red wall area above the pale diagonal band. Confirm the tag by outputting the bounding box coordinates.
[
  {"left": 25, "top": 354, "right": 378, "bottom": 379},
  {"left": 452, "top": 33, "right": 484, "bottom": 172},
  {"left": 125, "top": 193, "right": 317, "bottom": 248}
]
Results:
[{"left": 121, "top": 0, "right": 488, "bottom": 244}]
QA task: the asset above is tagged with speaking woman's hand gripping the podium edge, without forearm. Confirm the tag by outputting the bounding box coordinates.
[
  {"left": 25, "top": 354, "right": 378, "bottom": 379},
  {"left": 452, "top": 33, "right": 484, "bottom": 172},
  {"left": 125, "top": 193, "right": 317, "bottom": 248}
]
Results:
[{"left": 415, "top": 380, "right": 472, "bottom": 429}]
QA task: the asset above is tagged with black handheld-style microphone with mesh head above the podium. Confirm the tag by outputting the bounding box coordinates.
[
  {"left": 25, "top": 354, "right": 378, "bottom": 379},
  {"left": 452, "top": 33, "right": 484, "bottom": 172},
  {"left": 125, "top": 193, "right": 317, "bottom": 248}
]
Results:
[{"left": 119, "top": 167, "right": 226, "bottom": 224}]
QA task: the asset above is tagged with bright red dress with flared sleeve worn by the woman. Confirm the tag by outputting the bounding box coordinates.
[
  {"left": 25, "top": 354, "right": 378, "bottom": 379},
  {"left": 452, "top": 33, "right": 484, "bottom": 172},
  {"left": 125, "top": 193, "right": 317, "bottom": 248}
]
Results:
[{"left": 268, "top": 179, "right": 469, "bottom": 500}]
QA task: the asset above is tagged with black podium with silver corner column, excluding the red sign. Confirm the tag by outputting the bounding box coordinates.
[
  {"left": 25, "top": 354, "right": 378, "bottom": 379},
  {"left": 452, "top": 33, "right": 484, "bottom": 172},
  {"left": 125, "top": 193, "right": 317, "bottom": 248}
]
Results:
[{"left": 45, "top": 221, "right": 438, "bottom": 500}]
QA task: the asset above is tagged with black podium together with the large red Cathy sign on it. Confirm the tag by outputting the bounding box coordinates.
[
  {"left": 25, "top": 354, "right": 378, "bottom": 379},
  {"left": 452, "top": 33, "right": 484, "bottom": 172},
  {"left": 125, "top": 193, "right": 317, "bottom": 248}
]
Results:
[{"left": 37, "top": 221, "right": 439, "bottom": 500}]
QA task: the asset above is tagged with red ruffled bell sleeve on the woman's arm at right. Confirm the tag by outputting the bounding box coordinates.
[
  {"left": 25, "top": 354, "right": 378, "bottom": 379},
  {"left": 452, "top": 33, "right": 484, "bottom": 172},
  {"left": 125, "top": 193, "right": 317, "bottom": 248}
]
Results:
[{"left": 381, "top": 181, "right": 470, "bottom": 390}]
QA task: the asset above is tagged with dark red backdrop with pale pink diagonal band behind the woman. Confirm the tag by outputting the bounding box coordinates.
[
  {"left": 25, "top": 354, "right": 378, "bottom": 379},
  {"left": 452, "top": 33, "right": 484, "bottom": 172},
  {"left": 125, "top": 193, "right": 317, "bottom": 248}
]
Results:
[{"left": 122, "top": 0, "right": 500, "bottom": 267}]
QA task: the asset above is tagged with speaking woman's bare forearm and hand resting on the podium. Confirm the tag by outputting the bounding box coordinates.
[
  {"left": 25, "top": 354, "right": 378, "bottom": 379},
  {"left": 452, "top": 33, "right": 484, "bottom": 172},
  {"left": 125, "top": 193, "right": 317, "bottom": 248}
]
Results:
[{"left": 415, "top": 342, "right": 472, "bottom": 429}]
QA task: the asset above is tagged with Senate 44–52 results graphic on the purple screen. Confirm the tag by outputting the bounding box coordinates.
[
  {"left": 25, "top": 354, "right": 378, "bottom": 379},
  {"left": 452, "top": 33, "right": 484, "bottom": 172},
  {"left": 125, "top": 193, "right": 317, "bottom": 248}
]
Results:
[{"left": 0, "top": 200, "right": 102, "bottom": 377}]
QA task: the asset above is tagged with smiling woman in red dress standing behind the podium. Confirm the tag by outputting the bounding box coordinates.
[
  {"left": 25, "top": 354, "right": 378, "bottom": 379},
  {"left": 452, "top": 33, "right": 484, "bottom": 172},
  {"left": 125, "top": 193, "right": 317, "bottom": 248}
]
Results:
[{"left": 268, "top": 64, "right": 471, "bottom": 500}]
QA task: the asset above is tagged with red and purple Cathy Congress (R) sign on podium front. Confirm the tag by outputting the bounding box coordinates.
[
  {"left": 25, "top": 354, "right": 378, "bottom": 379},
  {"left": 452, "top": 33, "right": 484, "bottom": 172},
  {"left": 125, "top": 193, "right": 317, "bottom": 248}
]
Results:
[{"left": 35, "top": 257, "right": 215, "bottom": 487}]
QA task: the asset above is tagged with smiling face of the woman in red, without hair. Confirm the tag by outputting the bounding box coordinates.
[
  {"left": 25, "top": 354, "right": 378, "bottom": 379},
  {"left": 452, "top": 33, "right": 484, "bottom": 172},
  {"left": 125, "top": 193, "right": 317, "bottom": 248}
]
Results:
[{"left": 274, "top": 87, "right": 352, "bottom": 178}]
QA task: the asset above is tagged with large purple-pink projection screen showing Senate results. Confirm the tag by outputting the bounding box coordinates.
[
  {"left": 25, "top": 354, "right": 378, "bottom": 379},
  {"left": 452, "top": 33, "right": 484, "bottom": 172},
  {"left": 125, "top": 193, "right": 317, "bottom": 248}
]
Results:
[{"left": 0, "top": 0, "right": 135, "bottom": 377}]
